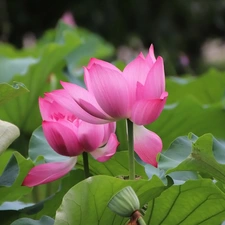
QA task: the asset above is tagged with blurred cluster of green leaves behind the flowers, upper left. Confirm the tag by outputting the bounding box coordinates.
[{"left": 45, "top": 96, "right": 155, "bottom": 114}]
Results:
[{"left": 0, "top": 23, "right": 113, "bottom": 155}]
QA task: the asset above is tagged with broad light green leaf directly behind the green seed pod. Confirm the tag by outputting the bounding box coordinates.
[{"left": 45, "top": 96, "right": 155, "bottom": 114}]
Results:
[{"left": 55, "top": 176, "right": 166, "bottom": 225}]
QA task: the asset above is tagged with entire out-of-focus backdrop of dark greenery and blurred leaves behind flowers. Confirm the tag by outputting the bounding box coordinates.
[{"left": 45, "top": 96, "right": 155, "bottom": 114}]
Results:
[{"left": 0, "top": 0, "right": 225, "bottom": 156}]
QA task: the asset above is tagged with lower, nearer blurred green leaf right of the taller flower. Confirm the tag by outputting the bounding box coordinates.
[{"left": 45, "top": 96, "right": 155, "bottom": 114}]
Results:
[{"left": 147, "top": 97, "right": 225, "bottom": 149}]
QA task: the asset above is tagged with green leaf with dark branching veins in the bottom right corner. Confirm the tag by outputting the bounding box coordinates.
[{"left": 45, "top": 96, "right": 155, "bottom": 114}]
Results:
[{"left": 145, "top": 180, "right": 225, "bottom": 225}]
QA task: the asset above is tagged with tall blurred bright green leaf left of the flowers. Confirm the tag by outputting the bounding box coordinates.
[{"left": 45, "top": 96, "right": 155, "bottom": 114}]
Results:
[{"left": 0, "top": 33, "right": 80, "bottom": 133}]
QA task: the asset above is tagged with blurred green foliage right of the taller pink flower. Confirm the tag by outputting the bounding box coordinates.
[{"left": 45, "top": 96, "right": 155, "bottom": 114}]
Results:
[{"left": 148, "top": 70, "right": 225, "bottom": 149}]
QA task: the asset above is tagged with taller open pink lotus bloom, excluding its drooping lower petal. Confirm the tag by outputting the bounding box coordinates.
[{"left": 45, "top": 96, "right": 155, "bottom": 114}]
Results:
[{"left": 61, "top": 45, "right": 168, "bottom": 125}]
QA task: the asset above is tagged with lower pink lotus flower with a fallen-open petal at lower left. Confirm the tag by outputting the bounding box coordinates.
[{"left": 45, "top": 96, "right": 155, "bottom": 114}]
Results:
[{"left": 23, "top": 90, "right": 119, "bottom": 187}]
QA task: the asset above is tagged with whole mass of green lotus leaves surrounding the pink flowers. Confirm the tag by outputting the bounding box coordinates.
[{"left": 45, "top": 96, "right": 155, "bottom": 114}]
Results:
[{"left": 0, "top": 23, "right": 225, "bottom": 225}]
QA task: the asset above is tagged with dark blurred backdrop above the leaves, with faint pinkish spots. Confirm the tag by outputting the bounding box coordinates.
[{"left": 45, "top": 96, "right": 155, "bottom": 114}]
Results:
[{"left": 0, "top": 0, "right": 225, "bottom": 75}]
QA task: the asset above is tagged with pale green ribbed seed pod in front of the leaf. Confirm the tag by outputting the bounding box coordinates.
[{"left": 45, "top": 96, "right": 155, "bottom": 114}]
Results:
[{"left": 108, "top": 186, "right": 140, "bottom": 217}]
